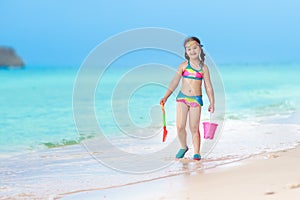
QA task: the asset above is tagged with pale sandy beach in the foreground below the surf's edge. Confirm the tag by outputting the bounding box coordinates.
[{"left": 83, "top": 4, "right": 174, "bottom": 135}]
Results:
[{"left": 60, "top": 145, "right": 300, "bottom": 200}]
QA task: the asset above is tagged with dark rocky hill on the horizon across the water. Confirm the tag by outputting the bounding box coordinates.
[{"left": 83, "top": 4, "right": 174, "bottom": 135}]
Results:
[{"left": 0, "top": 47, "right": 25, "bottom": 68}]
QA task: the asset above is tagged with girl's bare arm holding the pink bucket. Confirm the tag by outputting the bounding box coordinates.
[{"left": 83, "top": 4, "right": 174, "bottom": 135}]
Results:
[{"left": 203, "top": 65, "right": 215, "bottom": 112}]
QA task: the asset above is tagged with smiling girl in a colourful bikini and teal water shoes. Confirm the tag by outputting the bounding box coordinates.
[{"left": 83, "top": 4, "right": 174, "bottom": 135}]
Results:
[{"left": 160, "top": 37, "right": 214, "bottom": 160}]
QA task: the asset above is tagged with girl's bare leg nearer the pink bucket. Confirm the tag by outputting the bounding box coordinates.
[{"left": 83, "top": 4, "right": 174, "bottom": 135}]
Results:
[{"left": 189, "top": 107, "right": 201, "bottom": 154}]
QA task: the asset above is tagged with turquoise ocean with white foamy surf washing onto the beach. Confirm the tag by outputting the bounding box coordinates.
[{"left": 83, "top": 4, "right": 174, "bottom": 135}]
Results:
[{"left": 0, "top": 63, "right": 300, "bottom": 198}]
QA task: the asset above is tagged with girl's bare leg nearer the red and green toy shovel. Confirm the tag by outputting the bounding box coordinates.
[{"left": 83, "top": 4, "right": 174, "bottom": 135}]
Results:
[{"left": 176, "top": 102, "right": 189, "bottom": 149}]
